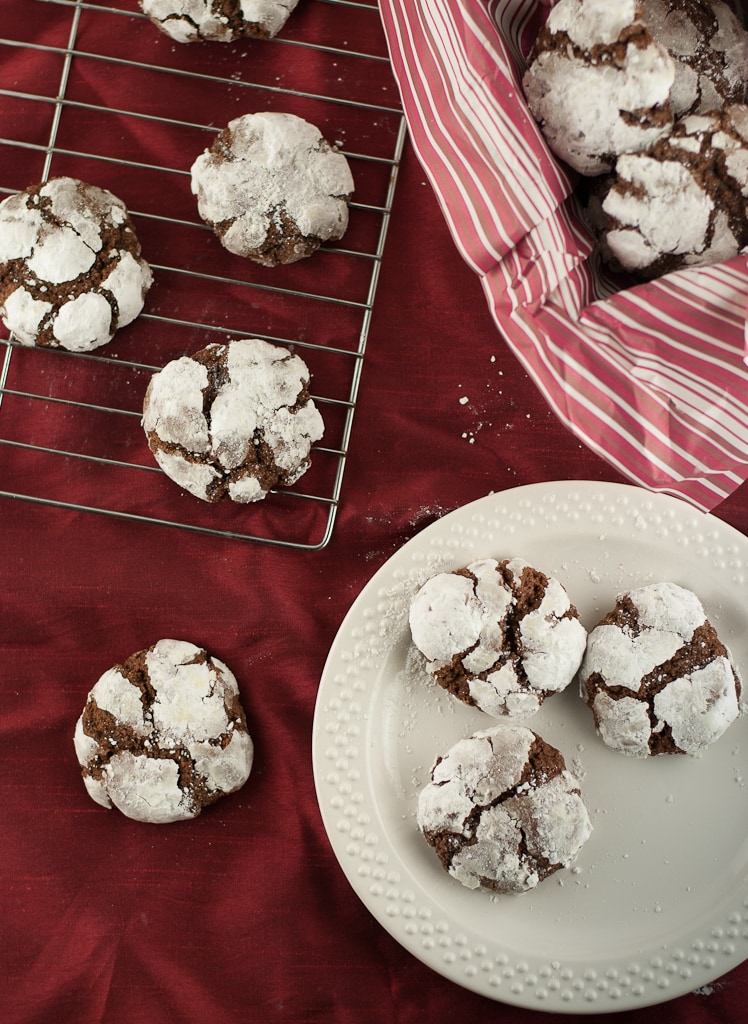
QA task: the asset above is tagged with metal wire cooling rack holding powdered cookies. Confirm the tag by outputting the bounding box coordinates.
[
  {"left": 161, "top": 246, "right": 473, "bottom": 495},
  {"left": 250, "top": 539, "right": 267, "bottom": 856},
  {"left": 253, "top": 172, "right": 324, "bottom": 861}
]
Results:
[{"left": 0, "top": 0, "right": 406, "bottom": 549}]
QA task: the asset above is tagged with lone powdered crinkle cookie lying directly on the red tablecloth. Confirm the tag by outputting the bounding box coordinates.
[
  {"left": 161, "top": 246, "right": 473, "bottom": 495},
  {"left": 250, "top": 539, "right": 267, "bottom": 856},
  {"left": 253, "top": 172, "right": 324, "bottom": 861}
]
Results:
[{"left": 75, "top": 640, "right": 253, "bottom": 823}]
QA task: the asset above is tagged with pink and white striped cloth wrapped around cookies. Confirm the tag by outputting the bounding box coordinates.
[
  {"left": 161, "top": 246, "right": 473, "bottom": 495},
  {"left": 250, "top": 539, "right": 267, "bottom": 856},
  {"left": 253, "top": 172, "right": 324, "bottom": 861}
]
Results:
[{"left": 380, "top": 0, "right": 748, "bottom": 510}]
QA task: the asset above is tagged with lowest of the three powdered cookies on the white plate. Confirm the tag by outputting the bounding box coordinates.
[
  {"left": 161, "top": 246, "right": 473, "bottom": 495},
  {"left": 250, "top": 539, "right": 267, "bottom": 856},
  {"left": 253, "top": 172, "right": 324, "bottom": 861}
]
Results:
[{"left": 417, "top": 725, "right": 592, "bottom": 894}]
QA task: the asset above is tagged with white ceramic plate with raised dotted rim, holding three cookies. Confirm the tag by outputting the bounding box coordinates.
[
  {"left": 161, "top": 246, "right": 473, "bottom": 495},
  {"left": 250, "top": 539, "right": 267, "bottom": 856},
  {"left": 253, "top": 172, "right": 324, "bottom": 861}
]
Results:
[{"left": 313, "top": 481, "right": 748, "bottom": 1013}]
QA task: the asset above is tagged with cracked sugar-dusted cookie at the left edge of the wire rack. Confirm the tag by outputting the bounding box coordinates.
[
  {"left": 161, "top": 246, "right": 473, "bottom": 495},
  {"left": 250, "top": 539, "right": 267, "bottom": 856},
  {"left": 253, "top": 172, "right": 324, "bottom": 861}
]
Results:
[{"left": 0, "top": 177, "right": 153, "bottom": 351}]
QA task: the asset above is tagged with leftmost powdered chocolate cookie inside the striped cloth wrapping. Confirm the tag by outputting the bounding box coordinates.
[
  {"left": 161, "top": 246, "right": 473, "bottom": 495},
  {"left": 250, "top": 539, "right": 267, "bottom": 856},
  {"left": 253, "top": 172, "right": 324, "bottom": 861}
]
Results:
[{"left": 523, "top": 0, "right": 675, "bottom": 174}]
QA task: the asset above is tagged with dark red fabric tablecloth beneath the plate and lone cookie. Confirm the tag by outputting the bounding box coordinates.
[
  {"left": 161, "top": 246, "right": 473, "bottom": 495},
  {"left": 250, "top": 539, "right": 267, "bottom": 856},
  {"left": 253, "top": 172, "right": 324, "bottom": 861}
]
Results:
[{"left": 0, "top": 0, "right": 748, "bottom": 1024}]
